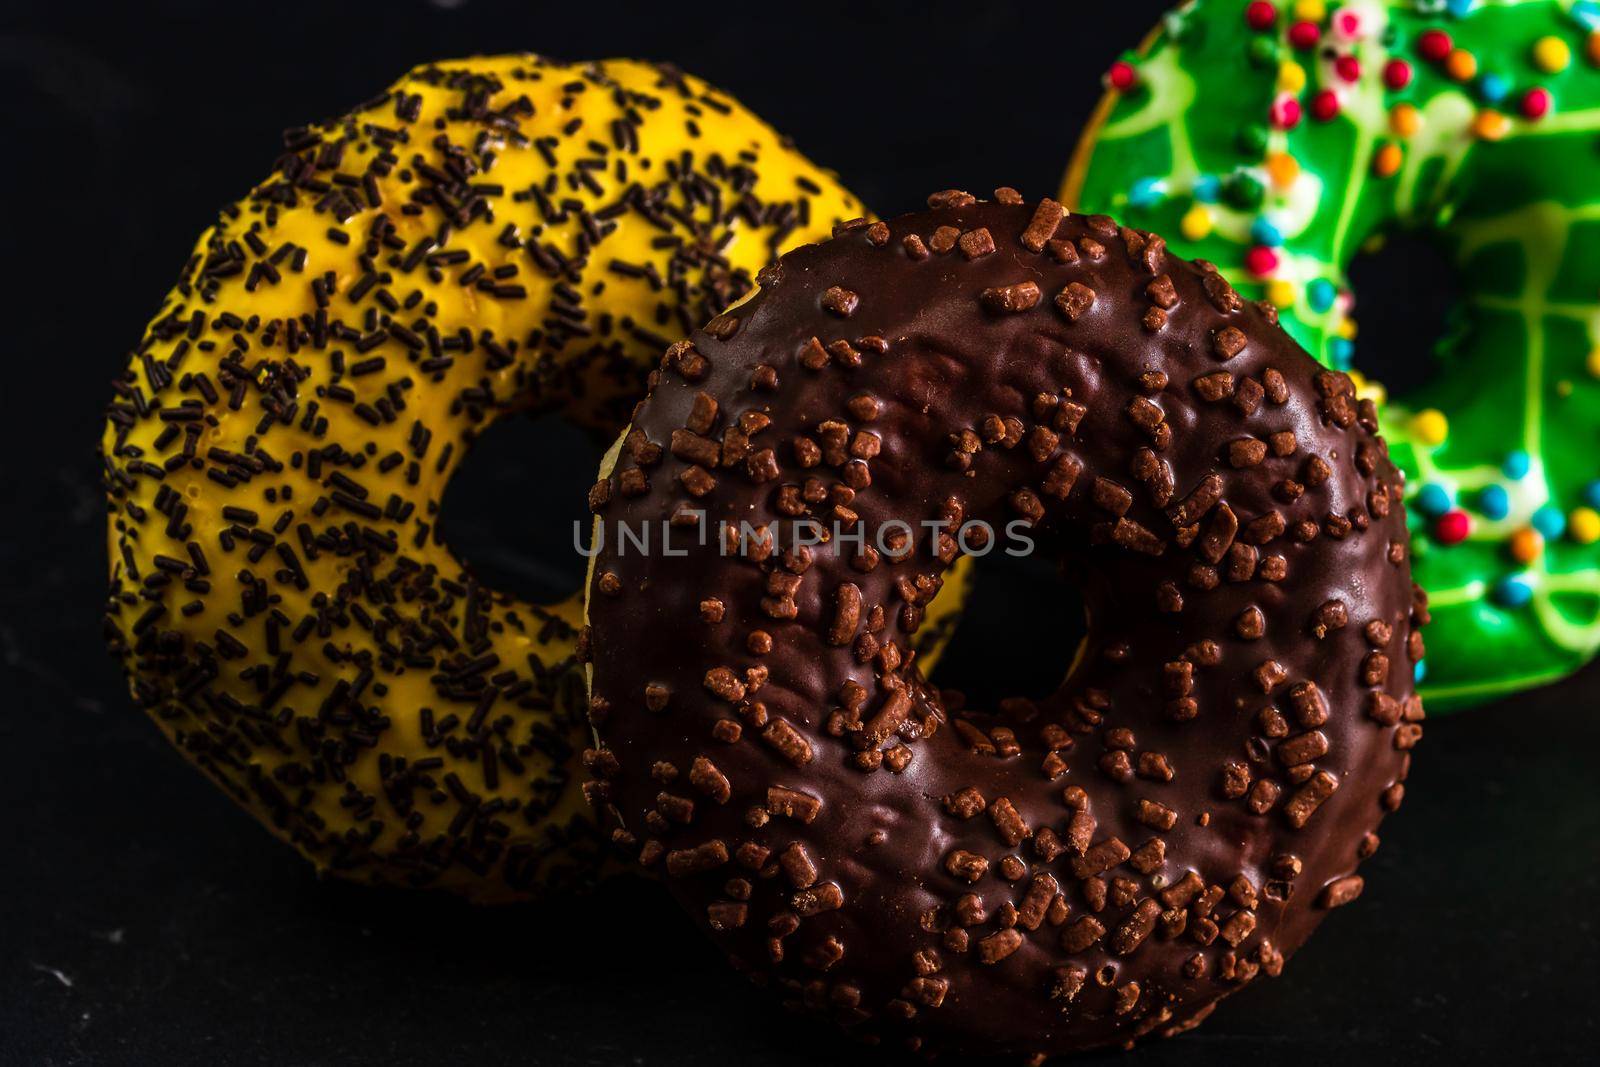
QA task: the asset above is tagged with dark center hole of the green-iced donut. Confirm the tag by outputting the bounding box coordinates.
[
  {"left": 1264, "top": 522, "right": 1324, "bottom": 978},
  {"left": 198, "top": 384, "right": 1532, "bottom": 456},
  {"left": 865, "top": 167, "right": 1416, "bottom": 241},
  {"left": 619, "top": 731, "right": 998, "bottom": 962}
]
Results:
[{"left": 1350, "top": 232, "right": 1459, "bottom": 397}]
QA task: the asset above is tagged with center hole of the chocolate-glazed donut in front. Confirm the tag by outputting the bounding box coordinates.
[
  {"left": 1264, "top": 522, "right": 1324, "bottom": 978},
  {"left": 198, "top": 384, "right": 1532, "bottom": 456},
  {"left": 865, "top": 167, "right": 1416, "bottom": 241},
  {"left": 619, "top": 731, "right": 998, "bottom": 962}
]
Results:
[{"left": 931, "top": 542, "right": 1088, "bottom": 712}]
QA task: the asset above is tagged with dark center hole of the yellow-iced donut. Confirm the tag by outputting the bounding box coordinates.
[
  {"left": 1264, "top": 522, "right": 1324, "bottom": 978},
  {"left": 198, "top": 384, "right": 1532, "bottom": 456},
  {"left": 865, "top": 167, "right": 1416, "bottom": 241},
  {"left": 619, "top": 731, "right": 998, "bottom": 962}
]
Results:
[{"left": 440, "top": 414, "right": 605, "bottom": 603}]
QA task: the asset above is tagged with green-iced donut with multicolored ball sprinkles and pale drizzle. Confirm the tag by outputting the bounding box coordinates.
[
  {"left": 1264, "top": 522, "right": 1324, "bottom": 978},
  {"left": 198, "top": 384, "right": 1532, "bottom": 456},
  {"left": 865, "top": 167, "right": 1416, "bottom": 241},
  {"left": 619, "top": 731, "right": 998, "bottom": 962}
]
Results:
[{"left": 1062, "top": 0, "right": 1600, "bottom": 710}]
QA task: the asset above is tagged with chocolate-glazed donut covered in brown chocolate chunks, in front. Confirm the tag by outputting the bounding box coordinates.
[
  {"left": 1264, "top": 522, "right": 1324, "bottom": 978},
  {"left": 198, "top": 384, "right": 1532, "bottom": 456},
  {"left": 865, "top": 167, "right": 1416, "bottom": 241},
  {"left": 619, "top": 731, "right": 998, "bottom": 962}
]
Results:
[{"left": 587, "top": 189, "right": 1426, "bottom": 1054}]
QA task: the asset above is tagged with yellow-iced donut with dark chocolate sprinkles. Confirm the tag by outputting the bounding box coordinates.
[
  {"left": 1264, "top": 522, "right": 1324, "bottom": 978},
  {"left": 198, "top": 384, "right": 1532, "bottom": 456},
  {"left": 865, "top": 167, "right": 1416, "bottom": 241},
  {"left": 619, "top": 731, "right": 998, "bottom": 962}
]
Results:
[{"left": 102, "top": 54, "right": 876, "bottom": 899}]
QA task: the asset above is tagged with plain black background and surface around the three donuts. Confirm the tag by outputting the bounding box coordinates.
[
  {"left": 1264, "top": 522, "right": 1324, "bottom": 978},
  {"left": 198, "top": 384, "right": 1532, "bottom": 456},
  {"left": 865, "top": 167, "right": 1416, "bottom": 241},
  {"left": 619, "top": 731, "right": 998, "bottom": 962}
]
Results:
[{"left": 0, "top": 0, "right": 1600, "bottom": 1065}]
